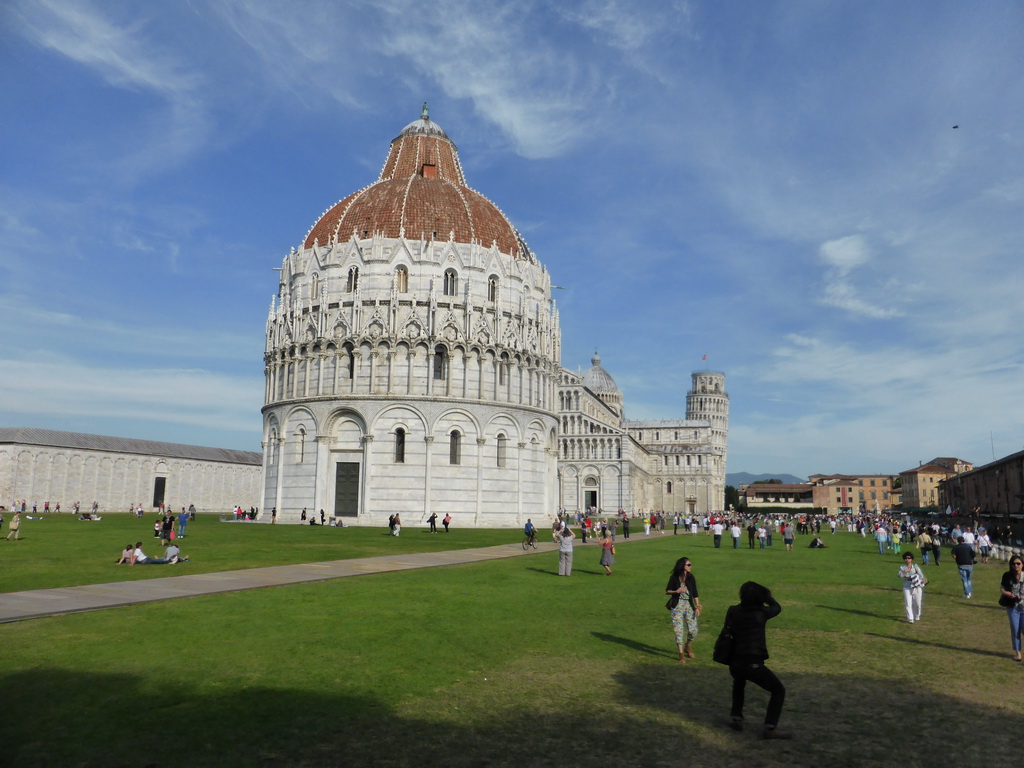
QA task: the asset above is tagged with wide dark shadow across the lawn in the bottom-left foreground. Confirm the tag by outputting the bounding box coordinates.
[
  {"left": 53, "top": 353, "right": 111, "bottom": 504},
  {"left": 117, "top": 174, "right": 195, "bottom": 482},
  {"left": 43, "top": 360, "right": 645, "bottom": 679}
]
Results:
[{"left": 0, "top": 666, "right": 806, "bottom": 768}]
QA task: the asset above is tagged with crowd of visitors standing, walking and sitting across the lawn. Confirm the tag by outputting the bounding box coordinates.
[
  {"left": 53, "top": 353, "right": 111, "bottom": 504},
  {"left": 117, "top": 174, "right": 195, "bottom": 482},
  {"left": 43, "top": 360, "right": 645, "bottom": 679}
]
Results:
[{"left": 6, "top": 501, "right": 1024, "bottom": 738}]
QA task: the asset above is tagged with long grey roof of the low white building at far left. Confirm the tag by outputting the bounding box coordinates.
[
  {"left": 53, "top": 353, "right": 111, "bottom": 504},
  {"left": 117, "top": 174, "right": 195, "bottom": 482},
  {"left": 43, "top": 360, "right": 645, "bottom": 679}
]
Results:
[{"left": 0, "top": 427, "right": 263, "bottom": 467}]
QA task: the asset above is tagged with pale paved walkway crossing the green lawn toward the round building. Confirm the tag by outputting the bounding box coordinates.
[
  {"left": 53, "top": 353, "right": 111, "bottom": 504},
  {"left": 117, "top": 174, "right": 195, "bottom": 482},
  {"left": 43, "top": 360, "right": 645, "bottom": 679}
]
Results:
[{"left": 0, "top": 541, "right": 589, "bottom": 624}]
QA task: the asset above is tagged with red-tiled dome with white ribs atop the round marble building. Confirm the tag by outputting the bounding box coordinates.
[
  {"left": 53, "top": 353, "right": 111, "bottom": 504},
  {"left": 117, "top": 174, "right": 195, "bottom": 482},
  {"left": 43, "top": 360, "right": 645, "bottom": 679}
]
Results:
[{"left": 303, "top": 104, "right": 532, "bottom": 260}]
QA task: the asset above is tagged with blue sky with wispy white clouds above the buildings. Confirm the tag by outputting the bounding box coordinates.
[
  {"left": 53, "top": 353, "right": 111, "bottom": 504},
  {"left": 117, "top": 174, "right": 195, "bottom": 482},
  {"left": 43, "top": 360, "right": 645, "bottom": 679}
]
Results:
[{"left": 0, "top": 0, "right": 1024, "bottom": 476}]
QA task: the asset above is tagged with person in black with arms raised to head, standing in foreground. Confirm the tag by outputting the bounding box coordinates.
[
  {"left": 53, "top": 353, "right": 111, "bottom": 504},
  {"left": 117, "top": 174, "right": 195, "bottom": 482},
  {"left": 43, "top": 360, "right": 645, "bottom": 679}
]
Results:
[{"left": 725, "top": 582, "right": 792, "bottom": 738}]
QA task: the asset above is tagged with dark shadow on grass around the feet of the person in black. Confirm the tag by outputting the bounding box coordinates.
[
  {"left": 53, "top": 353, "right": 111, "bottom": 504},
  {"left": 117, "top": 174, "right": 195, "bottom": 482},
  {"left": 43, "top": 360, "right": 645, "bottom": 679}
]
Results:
[{"left": 614, "top": 663, "right": 1024, "bottom": 768}]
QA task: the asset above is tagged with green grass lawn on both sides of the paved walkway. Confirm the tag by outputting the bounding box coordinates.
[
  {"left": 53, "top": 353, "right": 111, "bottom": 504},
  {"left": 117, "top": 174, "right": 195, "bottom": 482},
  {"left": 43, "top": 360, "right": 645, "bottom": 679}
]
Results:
[{"left": 0, "top": 521, "right": 1024, "bottom": 768}]
